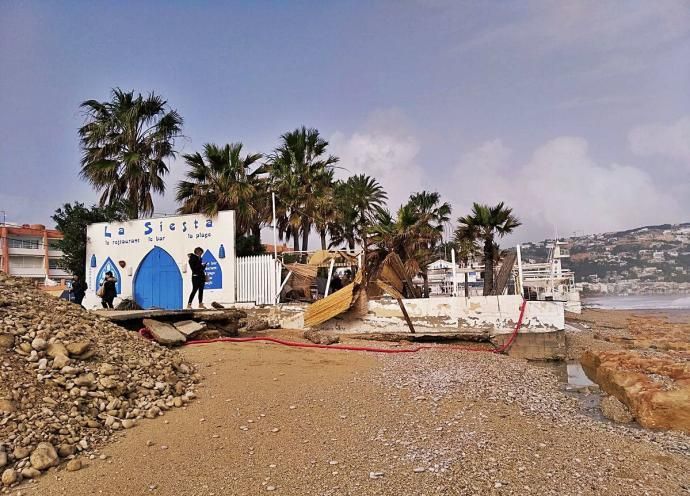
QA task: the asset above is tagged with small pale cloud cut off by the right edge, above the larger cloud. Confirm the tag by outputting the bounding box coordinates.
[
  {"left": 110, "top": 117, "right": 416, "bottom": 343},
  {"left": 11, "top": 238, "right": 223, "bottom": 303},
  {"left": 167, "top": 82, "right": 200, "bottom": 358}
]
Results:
[{"left": 628, "top": 116, "right": 690, "bottom": 163}]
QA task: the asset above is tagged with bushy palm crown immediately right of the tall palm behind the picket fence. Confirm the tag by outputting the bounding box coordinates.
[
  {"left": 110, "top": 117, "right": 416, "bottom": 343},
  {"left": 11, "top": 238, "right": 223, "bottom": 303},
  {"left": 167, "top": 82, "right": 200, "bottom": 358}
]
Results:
[{"left": 330, "top": 174, "right": 388, "bottom": 250}]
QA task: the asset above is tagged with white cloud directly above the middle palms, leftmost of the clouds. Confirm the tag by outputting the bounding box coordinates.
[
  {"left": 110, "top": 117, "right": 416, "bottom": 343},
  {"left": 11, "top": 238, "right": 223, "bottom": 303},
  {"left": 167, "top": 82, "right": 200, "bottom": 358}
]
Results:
[{"left": 329, "top": 110, "right": 424, "bottom": 211}]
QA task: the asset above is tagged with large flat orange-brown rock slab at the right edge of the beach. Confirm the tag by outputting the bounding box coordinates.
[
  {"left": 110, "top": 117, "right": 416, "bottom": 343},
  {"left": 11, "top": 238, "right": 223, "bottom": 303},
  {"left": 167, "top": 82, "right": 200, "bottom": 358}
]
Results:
[{"left": 580, "top": 350, "right": 690, "bottom": 433}]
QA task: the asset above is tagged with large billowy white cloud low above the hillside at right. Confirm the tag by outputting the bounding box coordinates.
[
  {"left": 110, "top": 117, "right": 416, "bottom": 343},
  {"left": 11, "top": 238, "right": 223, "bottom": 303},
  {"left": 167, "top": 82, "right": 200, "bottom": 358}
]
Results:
[{"left": 448, "top": 136, "right": 682, "bottom": 240}]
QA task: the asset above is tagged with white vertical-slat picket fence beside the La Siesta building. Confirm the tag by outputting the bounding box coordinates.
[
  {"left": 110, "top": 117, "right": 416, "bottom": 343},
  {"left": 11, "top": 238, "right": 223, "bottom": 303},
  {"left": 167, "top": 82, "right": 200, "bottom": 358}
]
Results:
[{"left": 235, "top": 255, "right": 280, "bottom": 305}]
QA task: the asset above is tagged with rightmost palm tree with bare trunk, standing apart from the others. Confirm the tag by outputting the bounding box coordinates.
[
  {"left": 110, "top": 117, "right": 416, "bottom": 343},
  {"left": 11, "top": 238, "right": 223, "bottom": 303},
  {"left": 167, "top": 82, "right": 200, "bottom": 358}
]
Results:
[{"left": 458, "top": 202, "right": 521, "bottom": 296}]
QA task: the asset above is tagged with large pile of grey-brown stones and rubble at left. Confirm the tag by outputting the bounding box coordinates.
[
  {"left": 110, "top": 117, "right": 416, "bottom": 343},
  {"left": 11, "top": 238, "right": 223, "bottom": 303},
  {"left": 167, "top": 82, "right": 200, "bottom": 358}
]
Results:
[{"left": 0, "top": 274, "right": 198, "bottom": 488}]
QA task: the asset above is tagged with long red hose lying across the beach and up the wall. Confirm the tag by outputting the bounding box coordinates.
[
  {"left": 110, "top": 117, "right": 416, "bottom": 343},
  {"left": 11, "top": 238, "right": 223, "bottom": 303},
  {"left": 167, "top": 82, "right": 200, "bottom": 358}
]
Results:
[{"left": 163, "top": 300, "right": 527, "bottom": 353}]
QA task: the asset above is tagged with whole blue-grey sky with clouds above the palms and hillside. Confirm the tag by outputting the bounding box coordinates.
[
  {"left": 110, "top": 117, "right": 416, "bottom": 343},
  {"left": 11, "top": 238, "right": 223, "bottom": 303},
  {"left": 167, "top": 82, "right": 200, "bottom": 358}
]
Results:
[{"left": 0, "top": 0, "right": 690, "bottom": 244}]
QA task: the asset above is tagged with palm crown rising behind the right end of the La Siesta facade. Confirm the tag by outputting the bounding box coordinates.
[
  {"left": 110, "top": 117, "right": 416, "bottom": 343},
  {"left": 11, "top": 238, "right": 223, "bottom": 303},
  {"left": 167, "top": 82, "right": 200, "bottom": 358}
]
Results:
[{"left": 176, "top": 143, "right": 267, "bottom": 238}]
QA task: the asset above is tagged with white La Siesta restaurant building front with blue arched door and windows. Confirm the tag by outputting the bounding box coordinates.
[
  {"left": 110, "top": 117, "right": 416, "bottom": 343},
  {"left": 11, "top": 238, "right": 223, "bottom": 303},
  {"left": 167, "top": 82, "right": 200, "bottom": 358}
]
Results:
[{"left": 84, "top": 211, "right": 235, "bottom": 309}]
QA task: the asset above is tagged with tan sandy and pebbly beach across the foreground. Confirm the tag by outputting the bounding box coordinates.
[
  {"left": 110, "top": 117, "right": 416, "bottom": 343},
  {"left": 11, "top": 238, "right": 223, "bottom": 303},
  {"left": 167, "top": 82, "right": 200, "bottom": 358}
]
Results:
[{"left": 30, "top": 310, "right": 690, "bottom": 496}]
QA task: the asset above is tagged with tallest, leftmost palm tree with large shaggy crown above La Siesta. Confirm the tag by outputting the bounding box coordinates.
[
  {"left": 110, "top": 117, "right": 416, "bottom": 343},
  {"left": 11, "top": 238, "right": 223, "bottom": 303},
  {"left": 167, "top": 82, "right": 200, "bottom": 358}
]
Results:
[{"left": 79, "top": 88, "right": 182, "bottom": 219}]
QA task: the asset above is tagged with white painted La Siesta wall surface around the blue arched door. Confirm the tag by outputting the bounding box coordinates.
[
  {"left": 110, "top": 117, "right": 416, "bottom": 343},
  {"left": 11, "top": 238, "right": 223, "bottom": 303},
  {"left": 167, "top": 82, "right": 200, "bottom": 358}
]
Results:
[{"left": 84, "top": 211, "right": 235, "bottom": 308}]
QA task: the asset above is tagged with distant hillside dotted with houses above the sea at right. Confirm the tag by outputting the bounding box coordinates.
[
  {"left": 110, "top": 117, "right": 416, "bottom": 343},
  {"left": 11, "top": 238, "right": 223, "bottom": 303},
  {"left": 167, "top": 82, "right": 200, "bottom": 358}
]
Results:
[{"left": 522, "top": 223, "right": 690, "bottom": 294}]
